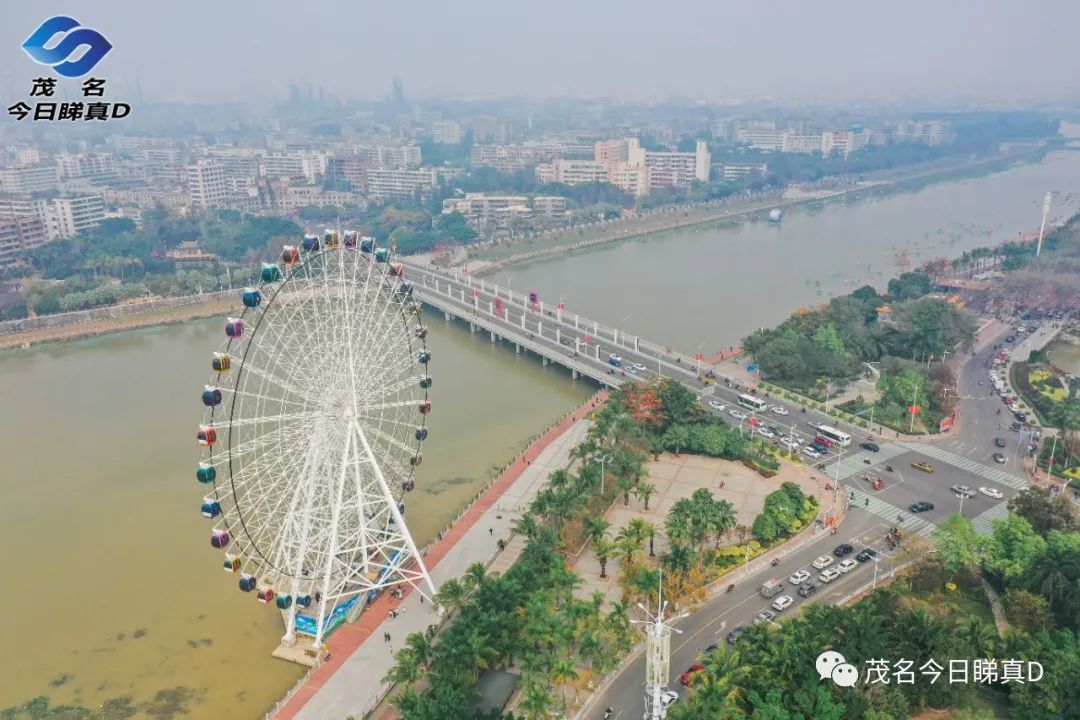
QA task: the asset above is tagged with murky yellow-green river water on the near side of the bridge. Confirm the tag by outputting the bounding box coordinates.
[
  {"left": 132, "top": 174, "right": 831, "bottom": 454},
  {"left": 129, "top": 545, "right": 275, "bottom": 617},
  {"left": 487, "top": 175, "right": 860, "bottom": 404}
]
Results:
[{"left": 0, "top": 315, "right": 594, "bottom": 720}]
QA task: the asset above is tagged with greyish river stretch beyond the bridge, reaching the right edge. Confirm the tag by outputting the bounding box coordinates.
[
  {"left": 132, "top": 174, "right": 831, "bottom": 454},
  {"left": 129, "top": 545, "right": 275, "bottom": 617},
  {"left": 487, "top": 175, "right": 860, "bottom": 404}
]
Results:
[{"left": 490, "top": 145, "right": 1080, "bottom": 354}]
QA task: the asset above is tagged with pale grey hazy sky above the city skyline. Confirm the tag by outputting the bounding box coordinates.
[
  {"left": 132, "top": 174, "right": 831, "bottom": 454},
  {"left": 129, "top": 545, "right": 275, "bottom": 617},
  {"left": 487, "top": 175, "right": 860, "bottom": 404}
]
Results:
[{"left": 0, "top": 0, "right": 1080, "bottom": 105}]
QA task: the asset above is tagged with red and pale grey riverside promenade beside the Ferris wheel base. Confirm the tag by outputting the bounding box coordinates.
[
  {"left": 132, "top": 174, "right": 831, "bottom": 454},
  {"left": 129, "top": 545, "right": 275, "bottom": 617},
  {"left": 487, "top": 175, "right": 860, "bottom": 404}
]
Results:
[{"left": 273, "top": 399, "right": 598, "bottom": 720}]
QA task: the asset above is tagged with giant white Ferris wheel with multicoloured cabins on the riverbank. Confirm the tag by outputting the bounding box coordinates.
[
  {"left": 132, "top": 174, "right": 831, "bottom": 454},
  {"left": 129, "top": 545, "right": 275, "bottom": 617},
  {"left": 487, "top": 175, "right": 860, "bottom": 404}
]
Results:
[{"left": 195, "top": 230, "right": 435, "bottom": 648}]
